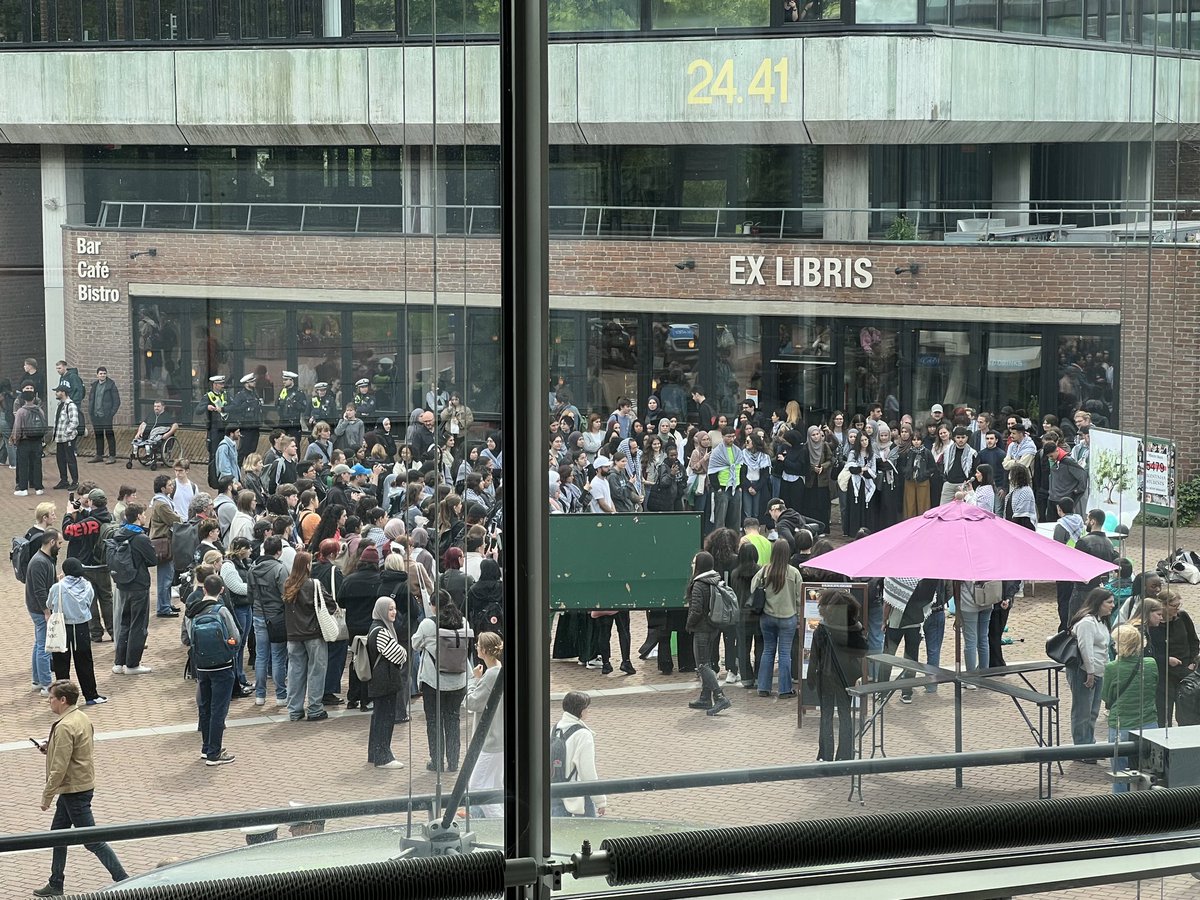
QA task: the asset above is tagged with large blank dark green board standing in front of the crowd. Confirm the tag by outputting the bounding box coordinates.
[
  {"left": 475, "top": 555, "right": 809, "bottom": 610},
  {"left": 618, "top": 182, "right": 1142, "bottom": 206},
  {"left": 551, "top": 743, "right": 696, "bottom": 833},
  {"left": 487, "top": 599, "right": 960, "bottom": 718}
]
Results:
[{"left": 550, "top": 512, "right": 701, "bottom": 610}]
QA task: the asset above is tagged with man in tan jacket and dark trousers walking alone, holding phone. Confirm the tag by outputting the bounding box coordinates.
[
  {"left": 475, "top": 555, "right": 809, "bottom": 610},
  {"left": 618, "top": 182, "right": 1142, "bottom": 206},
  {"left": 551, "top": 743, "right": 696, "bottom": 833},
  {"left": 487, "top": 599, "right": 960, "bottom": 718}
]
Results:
[{"left": 34, "top": 682, "right": 128, "bottom": 896}]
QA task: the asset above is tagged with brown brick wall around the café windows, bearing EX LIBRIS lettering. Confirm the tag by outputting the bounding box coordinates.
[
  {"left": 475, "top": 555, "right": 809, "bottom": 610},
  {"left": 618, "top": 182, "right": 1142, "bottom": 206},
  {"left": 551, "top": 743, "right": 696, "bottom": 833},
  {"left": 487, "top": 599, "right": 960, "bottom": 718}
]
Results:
[{"left": 64, "top": 230, "right": 1200, "bottom": 470}]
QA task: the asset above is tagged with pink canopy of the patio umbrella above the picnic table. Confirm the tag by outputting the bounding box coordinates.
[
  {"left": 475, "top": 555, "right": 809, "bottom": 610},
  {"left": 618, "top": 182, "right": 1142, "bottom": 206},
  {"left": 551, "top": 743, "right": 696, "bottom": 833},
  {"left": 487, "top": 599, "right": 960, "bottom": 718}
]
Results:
[{"left": 812, "top": 500, "right": 1114, "bottom": 581}]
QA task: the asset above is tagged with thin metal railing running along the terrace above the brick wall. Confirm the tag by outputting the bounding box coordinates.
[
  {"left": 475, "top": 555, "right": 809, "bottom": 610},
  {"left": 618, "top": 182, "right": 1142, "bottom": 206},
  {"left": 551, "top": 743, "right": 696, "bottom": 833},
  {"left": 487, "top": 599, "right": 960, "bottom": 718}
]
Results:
[{"left": 96, "top": 199, "right": 1200, "bottom": 242}]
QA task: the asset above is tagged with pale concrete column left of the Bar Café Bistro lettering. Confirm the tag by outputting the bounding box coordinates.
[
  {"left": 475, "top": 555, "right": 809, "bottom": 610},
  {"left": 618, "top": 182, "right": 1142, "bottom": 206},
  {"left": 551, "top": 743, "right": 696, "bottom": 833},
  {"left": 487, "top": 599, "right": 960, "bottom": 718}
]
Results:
[{"left": 41, "top": 144, "right": 84, "bottom": 368}]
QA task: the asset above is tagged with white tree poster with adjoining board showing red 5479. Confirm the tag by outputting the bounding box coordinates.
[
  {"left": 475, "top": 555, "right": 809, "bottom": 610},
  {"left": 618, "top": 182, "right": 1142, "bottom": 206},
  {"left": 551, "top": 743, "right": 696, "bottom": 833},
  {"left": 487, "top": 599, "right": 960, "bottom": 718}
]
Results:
[{"left": 1087, "top": 427, "right": 1176, "bottom": 527}]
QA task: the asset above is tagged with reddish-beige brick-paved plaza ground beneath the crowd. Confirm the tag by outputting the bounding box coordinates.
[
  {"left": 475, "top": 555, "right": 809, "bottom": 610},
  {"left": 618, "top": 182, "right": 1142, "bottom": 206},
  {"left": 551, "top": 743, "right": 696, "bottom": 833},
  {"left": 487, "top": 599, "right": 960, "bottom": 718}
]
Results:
[{"left": 0, "top": 448, "right": 1200, "bottom": 900}]
